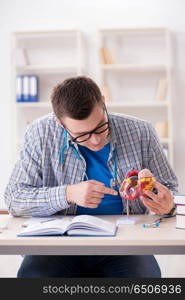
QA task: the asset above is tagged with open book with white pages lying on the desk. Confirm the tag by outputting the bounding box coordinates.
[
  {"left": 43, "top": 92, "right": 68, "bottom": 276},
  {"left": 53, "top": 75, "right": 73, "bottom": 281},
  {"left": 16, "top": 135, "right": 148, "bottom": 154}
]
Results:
[{"left": 18, "top": 215, "right": 117, "bottom": 236}]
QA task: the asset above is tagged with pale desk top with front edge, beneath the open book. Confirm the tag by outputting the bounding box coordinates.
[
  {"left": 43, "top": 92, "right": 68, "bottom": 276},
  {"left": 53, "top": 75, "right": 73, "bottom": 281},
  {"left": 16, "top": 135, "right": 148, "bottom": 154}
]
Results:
[{"left": 0, "top": 215, "right": 185, "bottom": 255}]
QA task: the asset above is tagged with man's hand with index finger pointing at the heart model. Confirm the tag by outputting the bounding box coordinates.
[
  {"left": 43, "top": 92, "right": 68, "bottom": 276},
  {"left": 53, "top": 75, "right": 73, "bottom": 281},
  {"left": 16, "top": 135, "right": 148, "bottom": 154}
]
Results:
[{"left": 66, "top": 180, "right": 118, "bottom": 208}]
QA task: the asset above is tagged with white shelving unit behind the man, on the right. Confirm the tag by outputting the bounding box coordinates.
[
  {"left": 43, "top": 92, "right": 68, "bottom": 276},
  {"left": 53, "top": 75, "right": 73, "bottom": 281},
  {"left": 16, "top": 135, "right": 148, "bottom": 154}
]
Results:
[{"left": 98, "top": 28, "right": 173, "bottom": 165}]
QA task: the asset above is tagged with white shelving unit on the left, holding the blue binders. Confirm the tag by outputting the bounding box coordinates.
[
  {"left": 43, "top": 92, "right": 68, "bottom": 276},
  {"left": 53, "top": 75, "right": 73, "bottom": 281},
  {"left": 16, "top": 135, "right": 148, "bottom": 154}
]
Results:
[{"left": 12, "top": 30, "right": 84, "bottom": 162}]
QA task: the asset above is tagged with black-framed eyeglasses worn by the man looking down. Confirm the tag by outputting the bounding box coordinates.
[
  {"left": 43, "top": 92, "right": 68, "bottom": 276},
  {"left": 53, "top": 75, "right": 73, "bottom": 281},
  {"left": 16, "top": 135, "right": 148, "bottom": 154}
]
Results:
[{"left": 60, "top": 105, "right": 110, "bottom": 144}]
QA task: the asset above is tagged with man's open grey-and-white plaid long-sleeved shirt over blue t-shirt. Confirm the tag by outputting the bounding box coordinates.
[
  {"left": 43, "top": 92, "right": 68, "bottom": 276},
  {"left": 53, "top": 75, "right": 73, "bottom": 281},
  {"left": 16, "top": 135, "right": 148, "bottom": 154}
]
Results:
[{"left": 5, "top": 113, "right": 177, "bottom": 216}]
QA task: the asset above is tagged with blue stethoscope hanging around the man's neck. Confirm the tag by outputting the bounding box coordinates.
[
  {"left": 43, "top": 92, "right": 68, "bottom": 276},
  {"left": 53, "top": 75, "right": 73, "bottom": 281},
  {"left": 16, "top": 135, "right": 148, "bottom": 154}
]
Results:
[{"left": 60, "top": 130, "right": 117, "bottom": 189}]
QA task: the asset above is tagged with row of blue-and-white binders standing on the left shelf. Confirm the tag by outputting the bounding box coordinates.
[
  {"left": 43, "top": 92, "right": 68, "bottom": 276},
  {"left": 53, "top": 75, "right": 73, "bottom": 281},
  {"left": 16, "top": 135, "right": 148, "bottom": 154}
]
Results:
[{"left": 16, "top": 75, "right": 39, "bottom": 102}]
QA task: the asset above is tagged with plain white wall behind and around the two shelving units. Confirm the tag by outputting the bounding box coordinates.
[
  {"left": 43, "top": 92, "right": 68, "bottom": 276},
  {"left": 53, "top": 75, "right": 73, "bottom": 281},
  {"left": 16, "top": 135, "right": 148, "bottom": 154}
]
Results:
[{"left": 0, "top": 0, "right": 185, "bottom": 207}]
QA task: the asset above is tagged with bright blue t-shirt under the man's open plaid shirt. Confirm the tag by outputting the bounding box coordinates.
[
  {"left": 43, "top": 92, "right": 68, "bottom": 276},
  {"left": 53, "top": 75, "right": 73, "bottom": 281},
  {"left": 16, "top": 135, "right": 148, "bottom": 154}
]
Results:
[{"left": 76, "top": 144, "right": 123, "bottom": 215}]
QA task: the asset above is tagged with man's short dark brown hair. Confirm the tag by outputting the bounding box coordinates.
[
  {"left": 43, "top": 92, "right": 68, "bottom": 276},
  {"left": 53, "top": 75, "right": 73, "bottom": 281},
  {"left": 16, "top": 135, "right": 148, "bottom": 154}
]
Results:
[{"left": 51, "top": 76, "right": 103, "bottom": 120}]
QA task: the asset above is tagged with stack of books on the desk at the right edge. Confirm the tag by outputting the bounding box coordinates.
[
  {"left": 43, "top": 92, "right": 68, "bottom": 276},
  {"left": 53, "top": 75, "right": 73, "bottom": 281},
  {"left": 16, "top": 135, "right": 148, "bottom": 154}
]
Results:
[{"left": 174, "top": 194, "right": 185, "bottom": 229}]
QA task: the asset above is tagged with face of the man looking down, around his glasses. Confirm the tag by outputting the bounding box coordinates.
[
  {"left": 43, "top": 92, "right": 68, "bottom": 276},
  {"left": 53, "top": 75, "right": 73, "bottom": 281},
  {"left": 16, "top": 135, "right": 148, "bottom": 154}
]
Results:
[{"left": 62, "top": 104, "right": 109, "bottom": 151}]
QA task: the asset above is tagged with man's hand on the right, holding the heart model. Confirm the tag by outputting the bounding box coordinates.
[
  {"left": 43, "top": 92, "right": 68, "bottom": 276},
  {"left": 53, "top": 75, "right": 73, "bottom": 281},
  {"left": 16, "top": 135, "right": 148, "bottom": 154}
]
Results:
[{"left": 140, "top": 182, "right": 174, "bottom": 215}]
